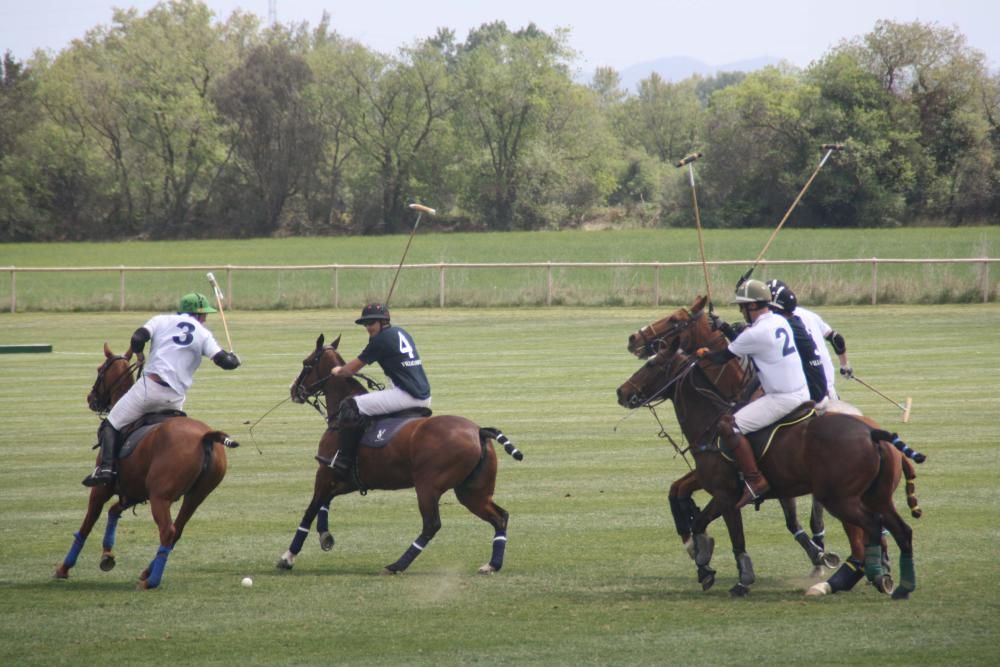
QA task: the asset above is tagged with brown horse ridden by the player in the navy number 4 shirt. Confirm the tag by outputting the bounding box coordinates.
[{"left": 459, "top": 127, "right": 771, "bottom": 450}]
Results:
[{"left": 277, "top": 334, "right": 523, "bottom": 574}]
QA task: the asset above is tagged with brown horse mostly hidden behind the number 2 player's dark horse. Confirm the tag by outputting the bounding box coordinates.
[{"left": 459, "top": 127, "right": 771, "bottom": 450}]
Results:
[{"left": 628, "top": 296, "right": 921, "bottom": 576}]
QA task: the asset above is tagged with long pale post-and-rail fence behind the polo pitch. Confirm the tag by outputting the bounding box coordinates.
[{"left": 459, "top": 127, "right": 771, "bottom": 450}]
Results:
[{"left": 0, "top": 257, "right": 1000, "bottom": 313}]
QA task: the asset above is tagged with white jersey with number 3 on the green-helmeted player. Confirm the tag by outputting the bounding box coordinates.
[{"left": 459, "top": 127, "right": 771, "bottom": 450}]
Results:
[{"left": 143, "top": 313, "right": 222, "bottom": 394}]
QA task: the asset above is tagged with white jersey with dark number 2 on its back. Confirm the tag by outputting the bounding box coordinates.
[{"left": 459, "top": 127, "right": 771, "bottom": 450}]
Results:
[{"left": 729, "top": 312, "right": 809, "bottom": 400}]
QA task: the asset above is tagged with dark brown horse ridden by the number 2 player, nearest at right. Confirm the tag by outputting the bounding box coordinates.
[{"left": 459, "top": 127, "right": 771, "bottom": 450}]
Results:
[{"left": 617, "top": 339, "right": 916, "bottom": 598}]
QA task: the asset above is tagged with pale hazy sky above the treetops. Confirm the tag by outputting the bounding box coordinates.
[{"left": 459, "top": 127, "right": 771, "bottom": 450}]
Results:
[{"left": 0, "top": 0, "right": 1000, "bottom": 70}]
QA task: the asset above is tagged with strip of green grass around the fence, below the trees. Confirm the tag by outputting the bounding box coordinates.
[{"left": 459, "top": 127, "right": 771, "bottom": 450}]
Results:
[{"left": 0, "top": 226, "right": 1000, "bottom": 312}]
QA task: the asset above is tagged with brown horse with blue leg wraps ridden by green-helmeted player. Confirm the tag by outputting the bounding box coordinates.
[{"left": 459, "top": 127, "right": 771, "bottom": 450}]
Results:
[{"left": 53, "top": 343, "right": 239, "bottom": 589}]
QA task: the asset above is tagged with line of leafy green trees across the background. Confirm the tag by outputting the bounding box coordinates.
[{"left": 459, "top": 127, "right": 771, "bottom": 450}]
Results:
[{"left": 0, "top": 0, "right": 1000, "bottom": 241}]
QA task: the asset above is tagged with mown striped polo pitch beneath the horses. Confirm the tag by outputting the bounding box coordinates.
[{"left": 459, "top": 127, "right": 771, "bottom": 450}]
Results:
[{"left": 0, "top": 304, "right": 1000, "bottom": 665}]
